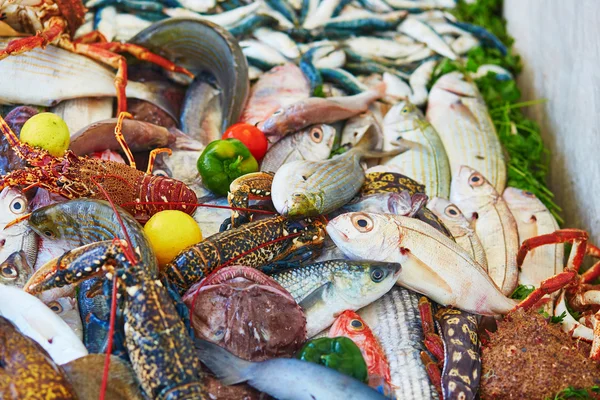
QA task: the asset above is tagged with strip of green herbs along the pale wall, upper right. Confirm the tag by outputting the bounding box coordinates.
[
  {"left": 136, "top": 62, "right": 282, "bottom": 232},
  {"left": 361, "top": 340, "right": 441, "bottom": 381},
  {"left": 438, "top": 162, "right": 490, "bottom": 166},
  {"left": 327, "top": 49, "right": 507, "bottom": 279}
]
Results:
[{"left": 430, "top": 0, "right": 563, "bottom": 224}]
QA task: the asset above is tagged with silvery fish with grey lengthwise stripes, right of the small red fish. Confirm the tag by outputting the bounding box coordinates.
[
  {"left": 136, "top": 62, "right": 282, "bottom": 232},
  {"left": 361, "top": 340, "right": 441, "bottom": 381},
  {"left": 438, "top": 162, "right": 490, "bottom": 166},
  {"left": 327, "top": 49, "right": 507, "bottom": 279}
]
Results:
[{"left": 358, "top": 286, "right": 437, "bottom": 400}]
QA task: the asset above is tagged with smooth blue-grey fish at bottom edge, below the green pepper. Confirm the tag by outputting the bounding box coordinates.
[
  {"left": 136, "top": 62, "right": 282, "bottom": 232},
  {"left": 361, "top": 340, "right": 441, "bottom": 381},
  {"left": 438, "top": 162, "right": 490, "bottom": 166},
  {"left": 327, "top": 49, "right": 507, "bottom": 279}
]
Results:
[{"left": 196, "top": 338, "right": 387, "bottom": 400}]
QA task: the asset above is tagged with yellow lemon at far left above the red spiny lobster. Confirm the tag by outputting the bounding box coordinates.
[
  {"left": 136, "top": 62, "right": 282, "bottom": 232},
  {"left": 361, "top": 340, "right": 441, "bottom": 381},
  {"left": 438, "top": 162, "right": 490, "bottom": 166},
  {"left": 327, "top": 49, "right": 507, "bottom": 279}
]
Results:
[{"left": 20, "top": 113, "right": 71, "bottom": 157}]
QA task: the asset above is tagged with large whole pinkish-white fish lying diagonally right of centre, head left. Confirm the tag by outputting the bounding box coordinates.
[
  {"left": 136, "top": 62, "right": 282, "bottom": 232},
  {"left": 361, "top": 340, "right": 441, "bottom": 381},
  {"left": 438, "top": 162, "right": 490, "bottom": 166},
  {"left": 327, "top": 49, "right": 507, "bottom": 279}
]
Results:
[{"left": 327, "top": 212, "right": 517, "bottom": 316}]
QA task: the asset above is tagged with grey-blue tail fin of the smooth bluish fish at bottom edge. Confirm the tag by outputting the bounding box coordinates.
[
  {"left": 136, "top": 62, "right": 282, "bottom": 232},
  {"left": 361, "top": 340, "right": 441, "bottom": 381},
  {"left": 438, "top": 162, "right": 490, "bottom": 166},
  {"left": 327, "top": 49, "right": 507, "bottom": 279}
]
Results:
[{"left": 194, "top": 338, "right": 252, "bottom": 386}]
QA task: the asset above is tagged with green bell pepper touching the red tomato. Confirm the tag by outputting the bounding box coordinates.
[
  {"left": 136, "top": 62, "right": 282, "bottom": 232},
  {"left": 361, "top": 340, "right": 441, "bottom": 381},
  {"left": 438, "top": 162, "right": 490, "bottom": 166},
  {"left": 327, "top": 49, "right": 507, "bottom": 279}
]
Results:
[{"left": 197, "top": 139, "right": 258, "bottom": 196}]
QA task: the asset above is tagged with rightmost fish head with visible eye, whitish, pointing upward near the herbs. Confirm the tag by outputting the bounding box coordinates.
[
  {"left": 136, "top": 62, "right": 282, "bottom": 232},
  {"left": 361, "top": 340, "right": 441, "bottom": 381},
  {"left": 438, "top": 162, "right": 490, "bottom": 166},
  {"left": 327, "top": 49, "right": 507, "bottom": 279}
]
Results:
[{"left": 450, "top": 165, "right": 500, "bottom": 221}]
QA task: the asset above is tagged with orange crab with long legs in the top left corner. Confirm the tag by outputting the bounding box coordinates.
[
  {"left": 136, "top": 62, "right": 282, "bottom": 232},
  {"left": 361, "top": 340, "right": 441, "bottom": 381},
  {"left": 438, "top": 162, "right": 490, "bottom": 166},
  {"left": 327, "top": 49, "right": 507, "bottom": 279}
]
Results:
[{"left": 0, "top": 0, "right": 194, "bottom": 112}]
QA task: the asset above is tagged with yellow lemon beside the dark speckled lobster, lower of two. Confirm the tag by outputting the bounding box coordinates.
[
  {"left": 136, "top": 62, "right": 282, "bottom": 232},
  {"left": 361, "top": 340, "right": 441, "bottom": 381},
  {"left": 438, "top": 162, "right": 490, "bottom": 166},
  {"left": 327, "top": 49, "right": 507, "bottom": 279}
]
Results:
[{"left": 144, "top": 210, "right": 202, "bottom": 266}]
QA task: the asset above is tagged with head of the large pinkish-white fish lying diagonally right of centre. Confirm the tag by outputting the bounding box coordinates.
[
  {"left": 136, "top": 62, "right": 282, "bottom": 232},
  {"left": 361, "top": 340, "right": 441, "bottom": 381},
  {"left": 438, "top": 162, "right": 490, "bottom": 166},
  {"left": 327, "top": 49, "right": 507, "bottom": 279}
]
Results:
[{"left": 326, "top": 212, "right": 400, "bottom": 262}]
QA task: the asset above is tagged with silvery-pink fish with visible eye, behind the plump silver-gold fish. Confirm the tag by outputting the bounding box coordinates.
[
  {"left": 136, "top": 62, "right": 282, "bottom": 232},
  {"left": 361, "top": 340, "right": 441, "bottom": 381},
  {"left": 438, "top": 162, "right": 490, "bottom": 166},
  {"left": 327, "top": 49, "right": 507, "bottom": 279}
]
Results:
[{"left": 260, "top": 124, "right": 335, "bottom": 172}]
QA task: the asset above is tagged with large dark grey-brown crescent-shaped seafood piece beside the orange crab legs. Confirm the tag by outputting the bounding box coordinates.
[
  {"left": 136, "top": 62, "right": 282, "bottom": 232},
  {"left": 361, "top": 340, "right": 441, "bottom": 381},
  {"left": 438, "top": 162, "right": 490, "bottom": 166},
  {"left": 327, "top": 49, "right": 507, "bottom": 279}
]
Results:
[{"left": 131, "top": 18, "right": 250, "bottom": 130}]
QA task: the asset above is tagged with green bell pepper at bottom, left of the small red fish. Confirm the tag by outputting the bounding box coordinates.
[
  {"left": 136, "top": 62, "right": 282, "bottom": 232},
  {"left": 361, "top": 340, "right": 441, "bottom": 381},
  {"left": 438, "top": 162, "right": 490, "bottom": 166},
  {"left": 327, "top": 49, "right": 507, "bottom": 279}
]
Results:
[{"left": 296, "top": 336, "right": 369, "bottom": 382}]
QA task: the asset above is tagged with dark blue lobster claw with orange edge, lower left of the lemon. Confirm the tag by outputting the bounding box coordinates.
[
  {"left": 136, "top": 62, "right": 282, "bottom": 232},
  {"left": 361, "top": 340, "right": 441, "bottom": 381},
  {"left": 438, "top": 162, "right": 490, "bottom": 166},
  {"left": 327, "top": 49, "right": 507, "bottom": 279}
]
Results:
[{"left": 23, "top": 240, "right": 124, "bottom": 294}]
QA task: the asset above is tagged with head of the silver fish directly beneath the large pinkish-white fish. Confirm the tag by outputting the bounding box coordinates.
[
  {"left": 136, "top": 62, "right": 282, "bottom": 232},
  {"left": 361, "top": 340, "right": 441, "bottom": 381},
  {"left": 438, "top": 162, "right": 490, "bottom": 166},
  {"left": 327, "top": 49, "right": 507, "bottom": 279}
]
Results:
[{"left": 332, "top": 260, "right": 401, "bottom": 309}]
